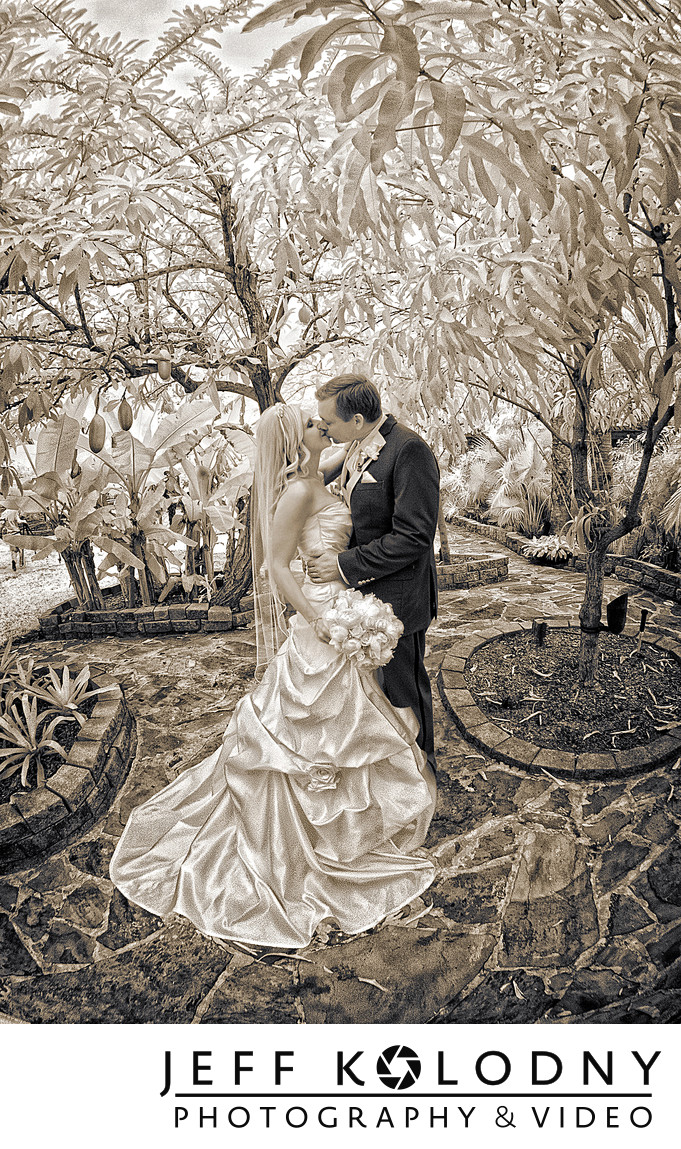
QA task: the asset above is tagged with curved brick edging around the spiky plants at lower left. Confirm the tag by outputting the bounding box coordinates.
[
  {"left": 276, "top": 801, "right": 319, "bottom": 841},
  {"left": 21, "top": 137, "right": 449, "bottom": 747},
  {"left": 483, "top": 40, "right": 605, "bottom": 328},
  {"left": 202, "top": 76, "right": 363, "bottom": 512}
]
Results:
[{"left": 0, "top": 674, "right": 137, "bottom": 874}]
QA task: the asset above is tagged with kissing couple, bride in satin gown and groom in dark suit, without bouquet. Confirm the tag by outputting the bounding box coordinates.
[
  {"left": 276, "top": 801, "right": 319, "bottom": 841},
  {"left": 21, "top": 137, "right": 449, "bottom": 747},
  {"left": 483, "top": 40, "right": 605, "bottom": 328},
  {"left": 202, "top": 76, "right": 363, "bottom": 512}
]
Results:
[{"left": 110, "top": 375, "right": 439, "bottom": 949}]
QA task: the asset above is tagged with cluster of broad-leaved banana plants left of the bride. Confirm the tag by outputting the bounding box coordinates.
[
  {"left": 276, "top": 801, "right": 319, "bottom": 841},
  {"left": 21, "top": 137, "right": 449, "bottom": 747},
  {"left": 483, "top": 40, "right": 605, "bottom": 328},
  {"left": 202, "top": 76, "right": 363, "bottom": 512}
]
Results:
[{"left": 0, "top": 398, "right": 253, "bottom": 610}]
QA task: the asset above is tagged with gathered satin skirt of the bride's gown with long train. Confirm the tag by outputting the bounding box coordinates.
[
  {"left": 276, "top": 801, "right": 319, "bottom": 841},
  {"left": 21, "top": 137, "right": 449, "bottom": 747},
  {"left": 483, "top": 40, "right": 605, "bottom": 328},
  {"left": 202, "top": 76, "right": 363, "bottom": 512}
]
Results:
[{"left": 110, "top": 602, "right": 435, "bottom": 949}]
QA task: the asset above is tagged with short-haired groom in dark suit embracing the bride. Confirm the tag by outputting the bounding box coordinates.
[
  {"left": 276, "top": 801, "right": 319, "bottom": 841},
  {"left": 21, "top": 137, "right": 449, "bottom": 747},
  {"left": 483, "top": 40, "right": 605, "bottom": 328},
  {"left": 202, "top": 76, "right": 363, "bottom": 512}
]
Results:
[{"left": 308, "top": 375, "right": 440, "bottom": 770}]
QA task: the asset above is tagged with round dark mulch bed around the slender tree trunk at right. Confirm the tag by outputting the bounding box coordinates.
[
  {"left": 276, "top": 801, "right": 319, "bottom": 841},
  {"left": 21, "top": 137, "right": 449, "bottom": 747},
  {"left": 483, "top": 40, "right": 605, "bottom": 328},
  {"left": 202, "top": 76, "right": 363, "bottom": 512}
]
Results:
[{"left": 465, "top": 630, "right": 681, "bottom": 754}]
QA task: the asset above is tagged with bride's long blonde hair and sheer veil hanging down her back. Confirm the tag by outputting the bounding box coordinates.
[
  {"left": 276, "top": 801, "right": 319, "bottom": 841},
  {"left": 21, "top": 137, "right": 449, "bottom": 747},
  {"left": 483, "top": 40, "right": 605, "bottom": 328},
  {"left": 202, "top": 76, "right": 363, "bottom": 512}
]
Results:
[{"left": 250, "top": 403, "right": 310, "bottom": 677}]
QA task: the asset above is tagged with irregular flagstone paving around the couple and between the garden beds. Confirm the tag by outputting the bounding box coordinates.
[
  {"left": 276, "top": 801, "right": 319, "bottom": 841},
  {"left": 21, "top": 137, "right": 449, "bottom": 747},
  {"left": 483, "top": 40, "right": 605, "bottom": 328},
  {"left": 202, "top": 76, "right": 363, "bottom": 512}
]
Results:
[{"left": 0, "top": 532, "right": 681, "bottom": 1024}]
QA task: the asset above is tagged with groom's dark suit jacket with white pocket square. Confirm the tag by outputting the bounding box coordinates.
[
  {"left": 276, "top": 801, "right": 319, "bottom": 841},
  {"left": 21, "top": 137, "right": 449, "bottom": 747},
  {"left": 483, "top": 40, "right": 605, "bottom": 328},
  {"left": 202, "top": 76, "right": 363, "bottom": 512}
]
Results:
[{"left": 339, "top": 415, "right": 440, "bottom": 634}]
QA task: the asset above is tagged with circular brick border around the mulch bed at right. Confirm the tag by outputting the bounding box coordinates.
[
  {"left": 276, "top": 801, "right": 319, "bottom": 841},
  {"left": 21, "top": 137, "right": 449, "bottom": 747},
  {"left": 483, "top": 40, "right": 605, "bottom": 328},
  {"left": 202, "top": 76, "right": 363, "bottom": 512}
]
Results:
[{"left": 438, "top": 618, "right": 681, "bottom": 781}]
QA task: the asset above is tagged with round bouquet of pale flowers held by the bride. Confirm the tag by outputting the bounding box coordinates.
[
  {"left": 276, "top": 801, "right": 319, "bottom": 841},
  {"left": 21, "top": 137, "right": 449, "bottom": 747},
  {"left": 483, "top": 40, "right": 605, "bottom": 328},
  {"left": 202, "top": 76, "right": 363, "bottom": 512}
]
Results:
[{"left": 322, "top": 587, "right": 404, "bottom": 670}]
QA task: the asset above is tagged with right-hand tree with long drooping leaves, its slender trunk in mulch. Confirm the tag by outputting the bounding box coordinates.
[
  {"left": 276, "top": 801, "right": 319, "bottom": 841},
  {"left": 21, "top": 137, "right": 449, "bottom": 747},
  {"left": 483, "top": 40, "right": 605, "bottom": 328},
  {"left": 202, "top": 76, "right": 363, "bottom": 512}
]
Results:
[{"left": 250, "top": 0, "right": 681, "bottom": 684}]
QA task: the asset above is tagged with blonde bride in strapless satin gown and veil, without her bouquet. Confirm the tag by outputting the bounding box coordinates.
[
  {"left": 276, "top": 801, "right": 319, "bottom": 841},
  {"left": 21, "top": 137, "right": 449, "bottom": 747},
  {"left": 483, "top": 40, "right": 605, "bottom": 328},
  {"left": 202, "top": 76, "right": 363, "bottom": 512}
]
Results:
[{"left": 110, "top": 403, "right": 435, "bottom": 949}]
